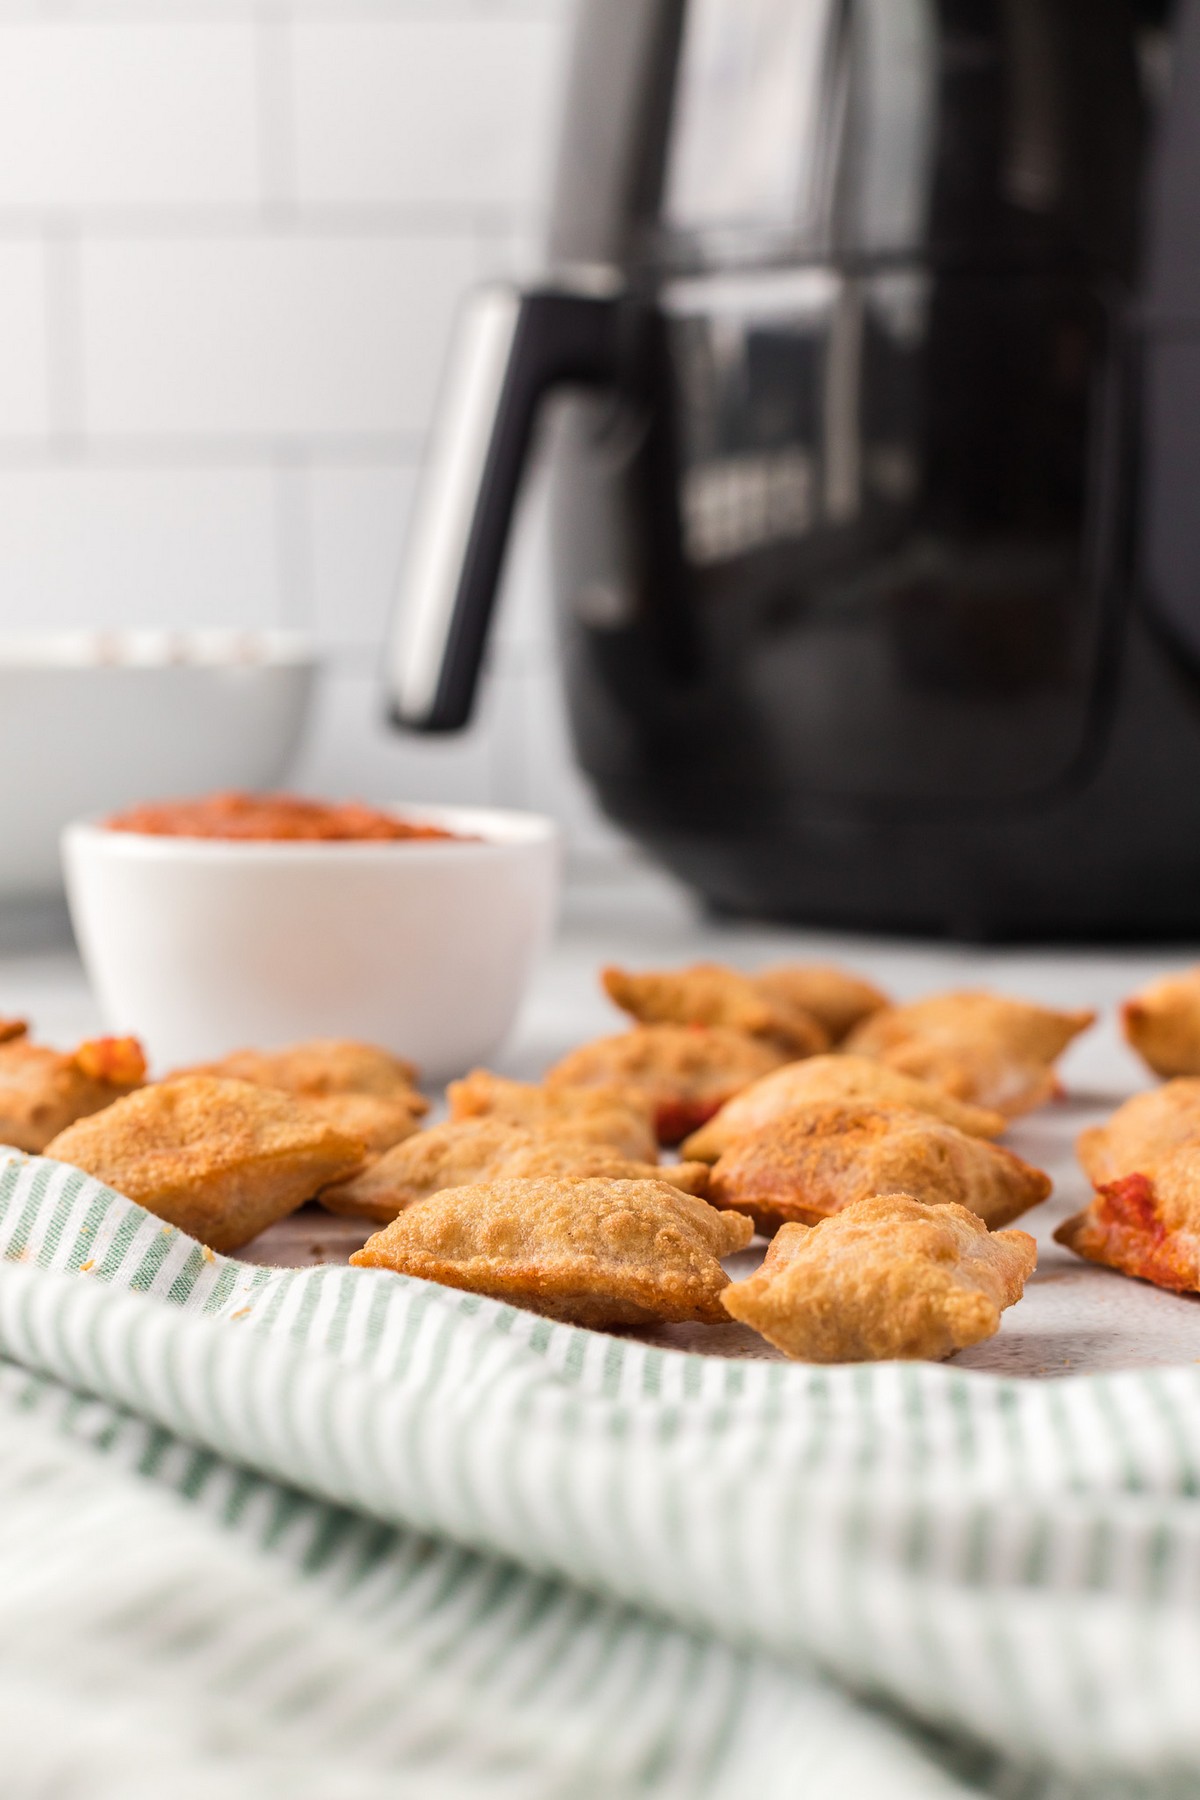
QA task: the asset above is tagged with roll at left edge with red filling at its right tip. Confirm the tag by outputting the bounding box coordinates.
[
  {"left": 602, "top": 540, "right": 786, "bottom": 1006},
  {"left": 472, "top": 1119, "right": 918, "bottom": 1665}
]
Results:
[{"left": 0, "top": 1037, "right": 146, "bottom": 1152}]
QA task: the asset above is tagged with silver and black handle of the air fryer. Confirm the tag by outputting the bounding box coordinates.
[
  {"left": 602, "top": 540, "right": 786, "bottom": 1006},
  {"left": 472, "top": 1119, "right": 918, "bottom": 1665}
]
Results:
[{"left": 385, "top": 286, "right": 621, "bottom": 731}]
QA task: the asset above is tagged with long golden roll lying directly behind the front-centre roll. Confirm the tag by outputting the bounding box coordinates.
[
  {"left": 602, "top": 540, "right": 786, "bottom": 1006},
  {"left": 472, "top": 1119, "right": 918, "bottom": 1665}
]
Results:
[{"left": 320, "top": 1118, "right": 709, "bottom": 1224}]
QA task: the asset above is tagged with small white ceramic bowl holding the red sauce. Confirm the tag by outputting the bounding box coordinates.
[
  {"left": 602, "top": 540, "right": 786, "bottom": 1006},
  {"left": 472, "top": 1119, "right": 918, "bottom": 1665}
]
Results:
[{"left": 63, "top": 806, "right": 560, "bottom": 1080}]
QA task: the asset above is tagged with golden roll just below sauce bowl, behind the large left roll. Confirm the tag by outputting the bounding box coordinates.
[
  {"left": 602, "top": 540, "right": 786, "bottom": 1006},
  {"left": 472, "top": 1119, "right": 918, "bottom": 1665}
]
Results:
[{"left": 175, "top": 1037, "right": 428, "bottom": 1152}]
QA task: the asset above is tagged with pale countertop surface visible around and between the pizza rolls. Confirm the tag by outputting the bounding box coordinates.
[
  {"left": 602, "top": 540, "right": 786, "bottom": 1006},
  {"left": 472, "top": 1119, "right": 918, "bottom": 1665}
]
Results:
[{"left": 0, "top": 866, "right": 1200, "bottom": 1375}]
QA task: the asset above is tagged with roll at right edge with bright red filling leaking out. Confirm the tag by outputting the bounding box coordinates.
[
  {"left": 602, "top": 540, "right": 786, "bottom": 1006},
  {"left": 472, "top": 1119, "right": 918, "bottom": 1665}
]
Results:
[{"left": 1054, "top": 1148, "right": 1200, "bottom": 1294}]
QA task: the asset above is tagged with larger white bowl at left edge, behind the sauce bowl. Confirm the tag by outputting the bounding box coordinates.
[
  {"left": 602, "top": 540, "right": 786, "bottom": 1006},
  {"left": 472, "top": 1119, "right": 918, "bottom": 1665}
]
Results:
[{"left": 0, "top": 632, "right": 317, "bottom": 900}]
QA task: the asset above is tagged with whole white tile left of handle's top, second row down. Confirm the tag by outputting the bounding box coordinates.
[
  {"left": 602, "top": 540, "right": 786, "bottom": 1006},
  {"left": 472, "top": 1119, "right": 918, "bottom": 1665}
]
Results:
[{"left": 79, "top": 230, "right": 475, "bottom": 433}]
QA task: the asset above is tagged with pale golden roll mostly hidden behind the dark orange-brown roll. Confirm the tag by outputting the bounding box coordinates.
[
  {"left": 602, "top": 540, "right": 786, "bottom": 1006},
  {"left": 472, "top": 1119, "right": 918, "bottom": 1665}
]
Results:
[{"left": 684, "top": 1053, "right": 1007, "bottom": 1163}]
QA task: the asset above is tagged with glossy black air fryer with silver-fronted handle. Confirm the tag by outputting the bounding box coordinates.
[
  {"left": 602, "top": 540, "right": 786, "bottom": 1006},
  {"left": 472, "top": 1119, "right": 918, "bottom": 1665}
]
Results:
[{"left": 389, "top": 0, "right": 1200, "bottom": 938}]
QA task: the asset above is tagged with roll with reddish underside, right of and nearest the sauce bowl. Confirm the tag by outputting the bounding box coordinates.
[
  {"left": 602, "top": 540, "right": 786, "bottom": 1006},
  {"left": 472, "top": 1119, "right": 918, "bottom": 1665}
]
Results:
[{"left": 545, "top": 1024, "right": 788, "bottom": 1143}]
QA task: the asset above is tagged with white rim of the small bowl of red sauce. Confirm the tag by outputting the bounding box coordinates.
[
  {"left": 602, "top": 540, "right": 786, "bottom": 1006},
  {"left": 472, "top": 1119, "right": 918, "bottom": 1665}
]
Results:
[{"left": 59, "top": 801, "right": 563, "bottom": 868}]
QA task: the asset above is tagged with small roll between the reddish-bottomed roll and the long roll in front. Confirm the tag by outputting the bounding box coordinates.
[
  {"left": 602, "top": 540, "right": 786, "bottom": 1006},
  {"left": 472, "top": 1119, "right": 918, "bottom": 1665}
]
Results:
[{"left": 446, "top": 1069, "right": 658, "bottom": 1163}]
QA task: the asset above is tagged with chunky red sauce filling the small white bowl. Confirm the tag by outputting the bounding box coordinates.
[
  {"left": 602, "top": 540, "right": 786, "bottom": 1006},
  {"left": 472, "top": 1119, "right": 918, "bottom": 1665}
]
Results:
[{"left": 104, "top": 794, "right": 470, "bottom": 844}]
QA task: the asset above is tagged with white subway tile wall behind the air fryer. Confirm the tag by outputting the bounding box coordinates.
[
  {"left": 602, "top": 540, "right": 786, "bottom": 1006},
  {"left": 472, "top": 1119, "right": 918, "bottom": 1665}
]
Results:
[{"left": 0, "top": 0, "right": 613, "bottom": 850}]
